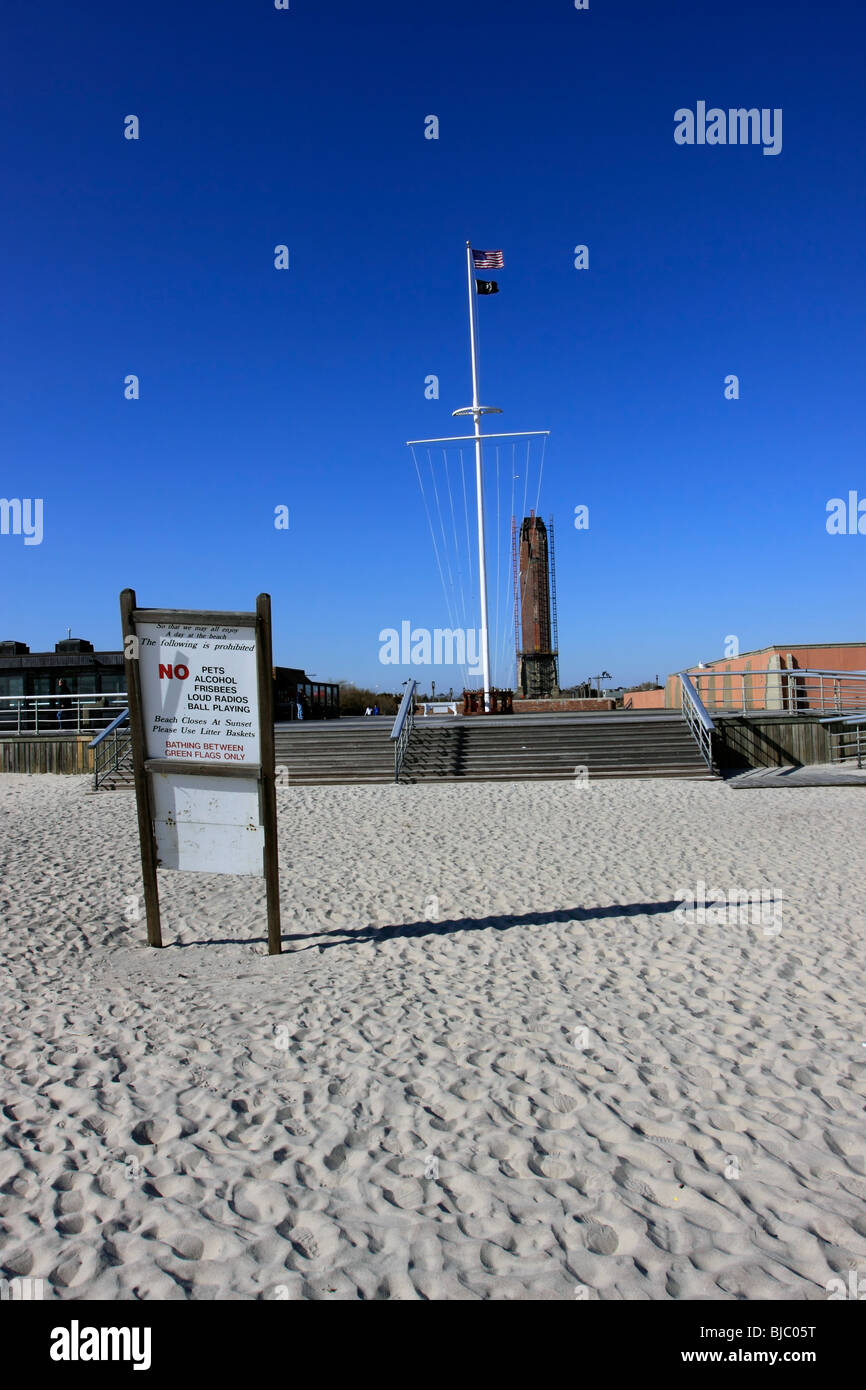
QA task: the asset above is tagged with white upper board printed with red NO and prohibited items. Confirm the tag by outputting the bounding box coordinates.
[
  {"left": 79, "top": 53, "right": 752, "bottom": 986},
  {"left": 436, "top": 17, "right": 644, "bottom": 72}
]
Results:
[{"left": 136, "top": 623, "right": 261, "bottom": 763}]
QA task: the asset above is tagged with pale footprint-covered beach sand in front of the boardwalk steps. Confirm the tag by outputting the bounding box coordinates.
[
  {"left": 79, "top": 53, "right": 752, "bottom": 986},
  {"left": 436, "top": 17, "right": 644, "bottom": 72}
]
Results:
[{"left": 0, "top": 776, "right": 866, "bottom": 1300}]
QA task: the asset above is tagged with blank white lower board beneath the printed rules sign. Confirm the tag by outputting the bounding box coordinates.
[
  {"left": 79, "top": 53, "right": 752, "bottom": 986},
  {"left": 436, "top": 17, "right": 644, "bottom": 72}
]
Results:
[{"left": 152, "top": 771, "right": 264, "bottom": 876}]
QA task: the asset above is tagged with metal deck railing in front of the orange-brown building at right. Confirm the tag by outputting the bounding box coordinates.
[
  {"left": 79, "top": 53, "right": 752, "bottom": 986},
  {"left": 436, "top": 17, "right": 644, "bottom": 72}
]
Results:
[{"left": 680, "top": 669, "right": 866, "bottom": 714}]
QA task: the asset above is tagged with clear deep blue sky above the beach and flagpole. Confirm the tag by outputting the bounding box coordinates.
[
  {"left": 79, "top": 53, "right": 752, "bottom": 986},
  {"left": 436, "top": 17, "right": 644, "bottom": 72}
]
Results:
[{"left": 0, "top": 0, "right": 866, "bottom": 688}]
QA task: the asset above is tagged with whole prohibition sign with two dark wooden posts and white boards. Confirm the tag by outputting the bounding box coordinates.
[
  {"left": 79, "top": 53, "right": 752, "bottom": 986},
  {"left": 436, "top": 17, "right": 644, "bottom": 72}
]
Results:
[{"left": 121, "top": 589, "right": 281, "bottom": 955}]
